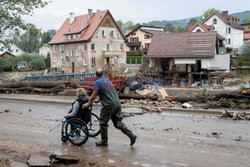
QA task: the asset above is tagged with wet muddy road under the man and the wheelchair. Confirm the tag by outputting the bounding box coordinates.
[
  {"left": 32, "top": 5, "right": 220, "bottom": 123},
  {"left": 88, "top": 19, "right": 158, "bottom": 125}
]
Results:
[{"left": 0, "top": 101, "right": 250, "bottom": 167}]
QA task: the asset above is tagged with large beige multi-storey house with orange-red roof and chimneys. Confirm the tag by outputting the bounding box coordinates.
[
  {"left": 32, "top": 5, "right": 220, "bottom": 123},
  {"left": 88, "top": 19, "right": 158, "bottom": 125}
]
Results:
[{"left": 49, "top": 9, "right": 126, "bottom": 73}]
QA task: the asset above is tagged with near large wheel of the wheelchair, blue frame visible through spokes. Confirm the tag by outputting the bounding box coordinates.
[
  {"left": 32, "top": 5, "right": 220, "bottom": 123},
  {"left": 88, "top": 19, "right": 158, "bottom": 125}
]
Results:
[{"left": 65, "top": 118, "right": 89, "bottom": 146}]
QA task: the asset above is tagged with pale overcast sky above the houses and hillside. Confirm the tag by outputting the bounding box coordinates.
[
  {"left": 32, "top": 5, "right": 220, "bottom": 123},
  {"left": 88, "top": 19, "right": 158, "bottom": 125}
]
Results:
[{"left": 25, "top": 0, "right": 250, "bottom": 30}]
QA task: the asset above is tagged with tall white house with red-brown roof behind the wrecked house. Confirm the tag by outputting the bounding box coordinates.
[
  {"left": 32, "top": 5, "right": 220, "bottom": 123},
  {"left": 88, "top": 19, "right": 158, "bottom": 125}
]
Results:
[{"left": 202, "top": 11, "right": 244, "bottom": 52}]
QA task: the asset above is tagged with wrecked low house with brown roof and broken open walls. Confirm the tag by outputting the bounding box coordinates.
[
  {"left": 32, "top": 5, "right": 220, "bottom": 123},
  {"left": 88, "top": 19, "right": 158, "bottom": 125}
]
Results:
[{"left": 146, "top": 31, "right": 230, "bottom": 85}]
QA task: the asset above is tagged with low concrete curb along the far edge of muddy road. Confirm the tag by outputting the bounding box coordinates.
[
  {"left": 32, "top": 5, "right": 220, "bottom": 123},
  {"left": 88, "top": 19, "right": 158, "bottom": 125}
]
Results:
[{"left": 0, "top": 97, "right": 250, "bottom": 115}]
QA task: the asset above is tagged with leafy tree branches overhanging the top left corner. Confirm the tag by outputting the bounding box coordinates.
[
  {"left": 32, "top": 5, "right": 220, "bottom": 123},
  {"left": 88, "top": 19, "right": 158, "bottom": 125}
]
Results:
[{"left": 0, "top": 0, "right": 48, "bottom": 45}]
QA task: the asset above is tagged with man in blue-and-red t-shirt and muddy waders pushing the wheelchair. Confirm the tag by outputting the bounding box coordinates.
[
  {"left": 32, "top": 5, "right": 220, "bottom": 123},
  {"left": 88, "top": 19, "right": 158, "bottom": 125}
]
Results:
[{"left": 84, "top": 69, "right": 137, "bottom": 146}]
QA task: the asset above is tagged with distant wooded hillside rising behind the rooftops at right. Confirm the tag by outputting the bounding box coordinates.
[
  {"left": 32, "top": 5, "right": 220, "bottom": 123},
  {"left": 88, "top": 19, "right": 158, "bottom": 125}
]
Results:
[{"left": 148, "top": 10, "right": 250, "bottom": 27}]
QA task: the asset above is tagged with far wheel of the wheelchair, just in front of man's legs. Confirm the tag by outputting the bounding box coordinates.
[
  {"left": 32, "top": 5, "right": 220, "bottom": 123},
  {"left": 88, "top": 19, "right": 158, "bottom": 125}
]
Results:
[{"left": 88, "top": 113, "right": 101, "bottom": 137}]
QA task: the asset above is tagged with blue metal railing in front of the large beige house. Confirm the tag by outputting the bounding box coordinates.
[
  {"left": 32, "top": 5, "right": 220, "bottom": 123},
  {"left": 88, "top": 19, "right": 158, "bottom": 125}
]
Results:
[{"left": 26, "top": 73, "right": 96, "bottom": 82}]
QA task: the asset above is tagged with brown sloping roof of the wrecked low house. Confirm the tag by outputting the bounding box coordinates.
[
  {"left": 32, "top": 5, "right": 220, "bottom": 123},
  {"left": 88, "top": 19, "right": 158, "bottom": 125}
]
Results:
[{"left": 147, "top": 32, "right": 217, "bottom": 58}]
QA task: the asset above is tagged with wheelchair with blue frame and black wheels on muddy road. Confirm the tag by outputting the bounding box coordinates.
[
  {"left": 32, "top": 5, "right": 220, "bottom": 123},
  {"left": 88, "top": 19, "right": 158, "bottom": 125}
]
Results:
[{"left": 61, "top": 113, "right": 100, "bottom": 146}]
